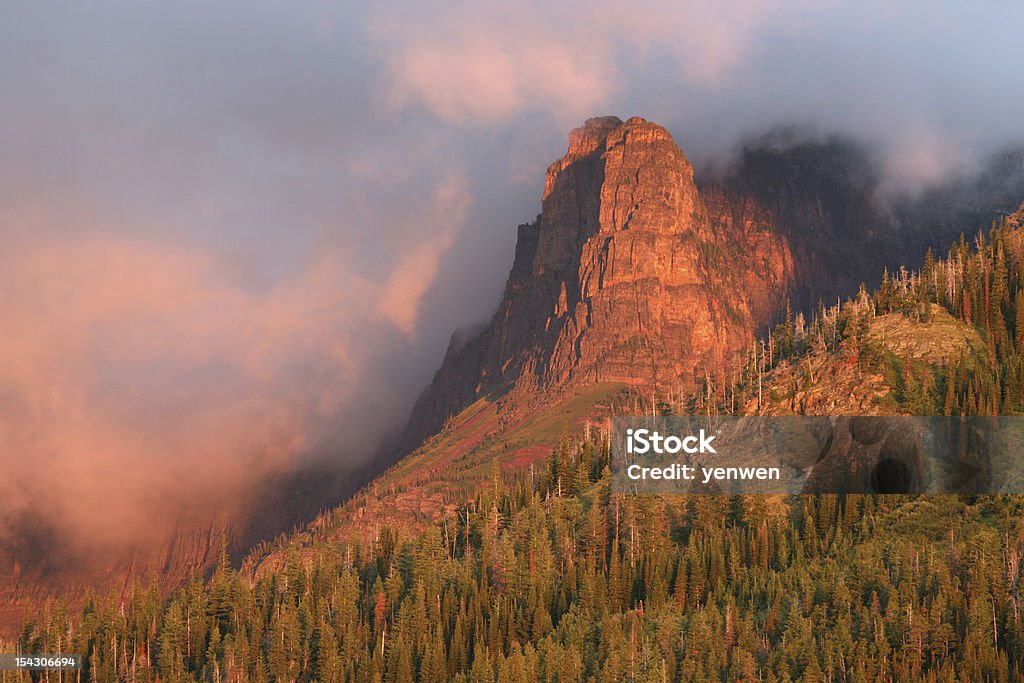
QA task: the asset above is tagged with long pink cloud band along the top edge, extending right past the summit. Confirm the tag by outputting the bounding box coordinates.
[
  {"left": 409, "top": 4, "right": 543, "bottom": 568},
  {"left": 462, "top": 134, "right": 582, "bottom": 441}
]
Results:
[{"left": 368, "top": 0, "right": 798, "bottom": 125}]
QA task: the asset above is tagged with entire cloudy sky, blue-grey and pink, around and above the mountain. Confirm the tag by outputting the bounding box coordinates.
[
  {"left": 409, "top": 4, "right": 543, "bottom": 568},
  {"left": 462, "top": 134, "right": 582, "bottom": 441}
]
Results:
[{"left": 0, "top": 0, "right": 1024, "bottom": 557}]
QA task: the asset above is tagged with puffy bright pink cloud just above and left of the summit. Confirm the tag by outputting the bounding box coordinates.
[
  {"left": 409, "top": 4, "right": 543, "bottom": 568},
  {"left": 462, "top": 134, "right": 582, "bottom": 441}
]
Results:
[{"left": 368, "top": 2, "right": 614, "bottom": 123}]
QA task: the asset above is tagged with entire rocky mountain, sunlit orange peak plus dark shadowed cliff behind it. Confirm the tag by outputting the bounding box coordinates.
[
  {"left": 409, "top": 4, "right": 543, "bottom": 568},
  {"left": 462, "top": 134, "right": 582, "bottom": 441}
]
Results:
[{"left": 407, "top": 117, "right": 1024, "bottom": 445}]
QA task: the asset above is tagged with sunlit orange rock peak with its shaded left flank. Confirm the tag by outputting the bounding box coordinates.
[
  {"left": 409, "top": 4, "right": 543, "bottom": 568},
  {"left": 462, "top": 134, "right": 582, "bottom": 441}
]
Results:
[{"left": 412, "top": 117, "right": 795, "bottom": 434}]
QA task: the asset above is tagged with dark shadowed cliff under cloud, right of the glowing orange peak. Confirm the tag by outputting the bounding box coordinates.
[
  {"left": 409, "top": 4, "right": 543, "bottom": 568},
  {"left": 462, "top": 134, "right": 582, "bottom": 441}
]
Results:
[{"left": 697, "top": 132, "right": 1024, "bottom": 312}]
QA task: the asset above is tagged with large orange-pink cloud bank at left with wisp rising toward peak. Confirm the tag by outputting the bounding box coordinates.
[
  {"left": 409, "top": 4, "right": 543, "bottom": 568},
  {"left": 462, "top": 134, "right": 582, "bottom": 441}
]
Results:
[{"left": 0, "top": 166, "right": 470, "bottom": 547}]
